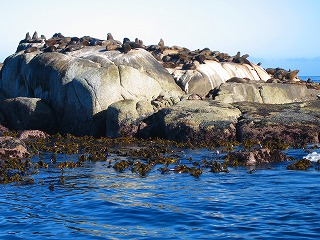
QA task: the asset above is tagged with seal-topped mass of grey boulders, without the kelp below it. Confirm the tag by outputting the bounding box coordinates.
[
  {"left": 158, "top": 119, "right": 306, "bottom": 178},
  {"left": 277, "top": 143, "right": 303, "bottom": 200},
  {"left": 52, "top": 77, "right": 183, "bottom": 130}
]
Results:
[{"left": 0, "top": 32, "right": 320, "bottom": 145}]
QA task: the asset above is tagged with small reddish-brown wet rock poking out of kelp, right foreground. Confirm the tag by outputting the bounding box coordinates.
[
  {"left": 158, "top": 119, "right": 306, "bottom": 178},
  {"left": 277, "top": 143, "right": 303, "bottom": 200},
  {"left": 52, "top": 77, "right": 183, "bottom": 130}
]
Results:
[{"left": 227, "top": 148, "right": 287, "bottom": 165}]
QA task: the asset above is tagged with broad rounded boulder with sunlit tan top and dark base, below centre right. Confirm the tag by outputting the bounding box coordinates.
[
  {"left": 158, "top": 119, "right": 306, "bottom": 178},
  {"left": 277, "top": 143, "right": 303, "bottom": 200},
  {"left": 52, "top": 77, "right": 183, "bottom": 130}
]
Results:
[{"left": 139, "top": 100, "right": 241, "bottom": 143}]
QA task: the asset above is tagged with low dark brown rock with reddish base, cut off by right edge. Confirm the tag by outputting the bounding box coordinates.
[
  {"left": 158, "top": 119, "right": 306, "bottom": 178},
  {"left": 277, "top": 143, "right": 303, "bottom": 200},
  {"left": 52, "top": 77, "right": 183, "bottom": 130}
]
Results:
[{"left": 234, "top": 100, "right": 320, "bottom": 145}]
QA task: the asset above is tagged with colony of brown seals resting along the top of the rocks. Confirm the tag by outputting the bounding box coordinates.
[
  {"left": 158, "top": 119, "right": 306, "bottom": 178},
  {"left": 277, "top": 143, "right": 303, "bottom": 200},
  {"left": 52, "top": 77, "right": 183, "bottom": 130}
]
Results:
[{"left": 16, "top": 32, "right": 308, "bottom": 83}]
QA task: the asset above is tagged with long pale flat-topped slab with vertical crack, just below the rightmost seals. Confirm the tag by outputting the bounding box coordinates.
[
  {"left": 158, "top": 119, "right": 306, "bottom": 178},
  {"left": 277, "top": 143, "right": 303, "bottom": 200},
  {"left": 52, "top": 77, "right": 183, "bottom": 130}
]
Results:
[{"left": 213, "top": 82, "right": 320, "bottom": 104}]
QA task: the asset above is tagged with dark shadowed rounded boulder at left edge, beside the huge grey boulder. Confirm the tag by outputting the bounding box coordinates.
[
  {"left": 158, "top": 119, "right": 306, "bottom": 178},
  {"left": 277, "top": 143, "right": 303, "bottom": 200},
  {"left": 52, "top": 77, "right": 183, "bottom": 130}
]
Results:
[{"left": 0, "top": 97, "right": 56, "bottom": 132}]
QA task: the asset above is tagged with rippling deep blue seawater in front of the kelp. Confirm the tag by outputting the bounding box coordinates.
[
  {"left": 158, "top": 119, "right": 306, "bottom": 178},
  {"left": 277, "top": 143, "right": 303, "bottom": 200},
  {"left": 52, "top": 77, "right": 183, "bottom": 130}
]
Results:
[{"left": 0, "top": 145, "right": 320, "bottom": 240}]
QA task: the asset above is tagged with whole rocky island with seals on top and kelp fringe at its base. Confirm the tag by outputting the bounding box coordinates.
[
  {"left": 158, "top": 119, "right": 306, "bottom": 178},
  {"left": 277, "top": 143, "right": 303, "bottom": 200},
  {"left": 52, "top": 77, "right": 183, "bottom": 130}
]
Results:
[{"left": 0, "top": 32, "right": 320, "bottom": 184}]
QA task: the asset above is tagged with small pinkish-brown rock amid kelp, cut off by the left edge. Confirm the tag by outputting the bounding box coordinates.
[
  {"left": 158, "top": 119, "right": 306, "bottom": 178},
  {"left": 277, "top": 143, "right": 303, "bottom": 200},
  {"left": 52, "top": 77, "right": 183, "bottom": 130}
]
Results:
[{"left": 0, "top": 136, "right": 29, "bottom": 159}]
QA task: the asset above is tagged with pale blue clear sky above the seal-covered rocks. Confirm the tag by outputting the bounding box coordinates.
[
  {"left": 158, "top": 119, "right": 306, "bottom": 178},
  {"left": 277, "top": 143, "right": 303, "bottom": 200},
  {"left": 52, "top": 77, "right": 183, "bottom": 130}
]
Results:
[{"left": 0, "top": 0, "right": 320, "bottom": 75}]
